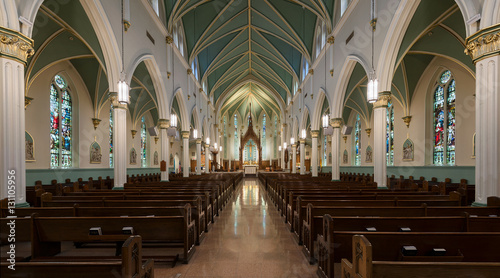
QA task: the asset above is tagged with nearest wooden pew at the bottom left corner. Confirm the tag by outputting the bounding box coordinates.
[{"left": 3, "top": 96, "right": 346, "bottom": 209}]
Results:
[{"left": 0, "top": 236, "right": 154, "bottom": 278}]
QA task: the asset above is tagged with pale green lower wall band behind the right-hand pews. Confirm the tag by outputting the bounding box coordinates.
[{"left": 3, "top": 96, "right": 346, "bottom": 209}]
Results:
[{"left": 321, "top": 166, "right": 476, "bottom": 184}]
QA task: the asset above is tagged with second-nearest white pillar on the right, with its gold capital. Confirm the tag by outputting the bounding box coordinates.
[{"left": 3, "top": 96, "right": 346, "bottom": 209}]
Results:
[{"left": 373, "top": 91, "right": 391, "bottom": 188}]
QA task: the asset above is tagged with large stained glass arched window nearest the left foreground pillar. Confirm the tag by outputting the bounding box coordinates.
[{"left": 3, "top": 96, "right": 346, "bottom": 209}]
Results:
[{"left": 50, "top": 75, "right": 73, "bottom": 168}]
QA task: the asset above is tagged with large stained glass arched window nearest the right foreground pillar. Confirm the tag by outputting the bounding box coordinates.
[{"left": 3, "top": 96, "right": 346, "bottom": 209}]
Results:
[{"left": 433, "top": 70, "right": 456, "bottom": 165}]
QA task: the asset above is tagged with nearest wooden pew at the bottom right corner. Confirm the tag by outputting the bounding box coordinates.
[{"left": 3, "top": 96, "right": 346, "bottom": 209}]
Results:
[{"left": 340, "top": 235, "right": 500, "bottom": 278}]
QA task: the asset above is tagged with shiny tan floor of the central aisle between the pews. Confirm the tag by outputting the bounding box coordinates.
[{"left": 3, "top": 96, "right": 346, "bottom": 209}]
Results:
[{"left": 155, "top": 178, "right": 317, "bottom": 278}]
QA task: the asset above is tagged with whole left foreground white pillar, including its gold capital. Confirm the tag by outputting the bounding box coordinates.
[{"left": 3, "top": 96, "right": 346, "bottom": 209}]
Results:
[{"left": 0, "top": 27, "right": 34, "bottom": 207}]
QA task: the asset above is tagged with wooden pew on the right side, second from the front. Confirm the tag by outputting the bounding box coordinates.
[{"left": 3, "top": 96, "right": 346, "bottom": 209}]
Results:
[{"left": 318, "top": 215, "right": 500, "bottom": 278}]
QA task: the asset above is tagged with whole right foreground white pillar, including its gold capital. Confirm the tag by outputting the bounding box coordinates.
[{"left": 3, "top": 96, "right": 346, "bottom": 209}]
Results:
[{"left": 466, "top": 25, "right": 500, "bottom": 206}]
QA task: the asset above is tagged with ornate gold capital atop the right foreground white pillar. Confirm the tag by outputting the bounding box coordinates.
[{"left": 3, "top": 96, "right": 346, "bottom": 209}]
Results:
[{"left": 464, "top": 24, "right": 500, "bottom": 64}]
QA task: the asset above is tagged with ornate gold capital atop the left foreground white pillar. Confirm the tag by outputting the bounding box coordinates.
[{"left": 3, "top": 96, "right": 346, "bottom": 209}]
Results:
[{"left": 0, "top": 27, "right": 35, "bottom": 65}]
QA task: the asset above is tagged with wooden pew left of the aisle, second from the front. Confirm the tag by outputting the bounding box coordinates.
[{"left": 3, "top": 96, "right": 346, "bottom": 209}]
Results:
[{"left": 31, "top": 204, "right": 196, "bottom": 263}]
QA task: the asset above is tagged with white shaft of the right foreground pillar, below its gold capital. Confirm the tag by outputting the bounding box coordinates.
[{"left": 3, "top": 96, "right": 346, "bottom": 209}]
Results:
[{"left": 474, "top": 55, "right": 500, "bottom": 206}]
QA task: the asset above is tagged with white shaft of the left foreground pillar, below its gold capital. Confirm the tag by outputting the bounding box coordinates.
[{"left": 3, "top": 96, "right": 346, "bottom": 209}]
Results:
[{"left": 0, "top": 57, "right": 27, "bottom": 207}]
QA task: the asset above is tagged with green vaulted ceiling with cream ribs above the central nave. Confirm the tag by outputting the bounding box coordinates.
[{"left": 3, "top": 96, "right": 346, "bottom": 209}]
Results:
[{"left": 164, "top": 0, "right": 334, "bottom": 117}]
